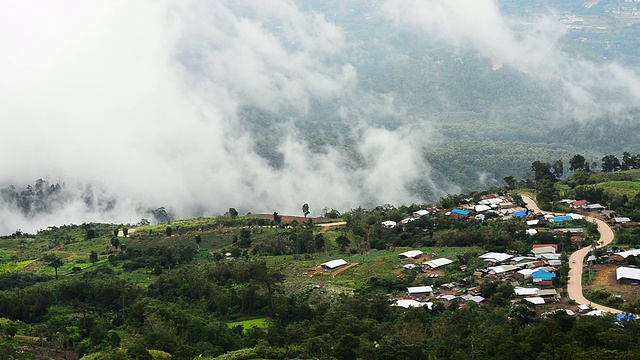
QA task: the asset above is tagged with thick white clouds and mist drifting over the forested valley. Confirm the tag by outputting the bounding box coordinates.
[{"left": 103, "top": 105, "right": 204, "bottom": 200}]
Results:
[{"left": 0, "top": 0, "right": 640, "bottom": 233}]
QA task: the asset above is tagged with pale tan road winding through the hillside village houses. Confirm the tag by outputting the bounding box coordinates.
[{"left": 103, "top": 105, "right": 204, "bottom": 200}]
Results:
[{"left": 522, "top": 195, "right": 622, "bottom": 314}]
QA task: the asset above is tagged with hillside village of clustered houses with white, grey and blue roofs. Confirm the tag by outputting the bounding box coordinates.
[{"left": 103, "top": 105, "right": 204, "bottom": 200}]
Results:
[{"left": 319, "top": 194, "right": 640, "bottom": 320}]
